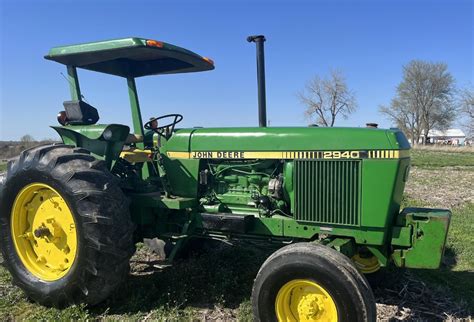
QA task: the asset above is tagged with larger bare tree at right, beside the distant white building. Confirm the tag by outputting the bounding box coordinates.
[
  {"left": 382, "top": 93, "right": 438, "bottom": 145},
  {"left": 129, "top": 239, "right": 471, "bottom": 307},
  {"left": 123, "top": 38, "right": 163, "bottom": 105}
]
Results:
[{"left": 380, "top": 60, "right": 455, "bottom": 144}]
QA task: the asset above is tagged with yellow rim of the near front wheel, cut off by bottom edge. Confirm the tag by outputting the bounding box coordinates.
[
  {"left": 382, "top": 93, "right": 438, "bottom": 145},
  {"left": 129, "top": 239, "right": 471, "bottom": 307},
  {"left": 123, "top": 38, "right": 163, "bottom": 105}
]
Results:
[{"left": 275, "top": 279, "right": 337, "bottom": 322}]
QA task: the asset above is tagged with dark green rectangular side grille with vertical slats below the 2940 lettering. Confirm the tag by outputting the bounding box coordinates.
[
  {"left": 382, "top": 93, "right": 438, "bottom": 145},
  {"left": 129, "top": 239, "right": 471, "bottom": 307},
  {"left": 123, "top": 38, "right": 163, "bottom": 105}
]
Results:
[{"left": 293, "top": 160, "right": 361, "bottom": 226}]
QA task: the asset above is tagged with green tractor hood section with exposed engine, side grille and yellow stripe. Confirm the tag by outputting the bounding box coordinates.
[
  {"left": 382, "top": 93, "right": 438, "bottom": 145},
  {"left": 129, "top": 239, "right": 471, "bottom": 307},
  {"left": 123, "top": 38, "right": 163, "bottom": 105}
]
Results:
[{"left": 161, "top": 128, "right": 409, "bottom": 244}]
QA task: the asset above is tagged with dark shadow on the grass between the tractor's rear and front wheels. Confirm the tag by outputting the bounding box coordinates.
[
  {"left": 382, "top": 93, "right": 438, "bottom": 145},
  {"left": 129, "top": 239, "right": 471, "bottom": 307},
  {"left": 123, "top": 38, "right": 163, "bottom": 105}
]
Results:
[{"left": 92, "top": 244, "right": 272, "bottom": 314}]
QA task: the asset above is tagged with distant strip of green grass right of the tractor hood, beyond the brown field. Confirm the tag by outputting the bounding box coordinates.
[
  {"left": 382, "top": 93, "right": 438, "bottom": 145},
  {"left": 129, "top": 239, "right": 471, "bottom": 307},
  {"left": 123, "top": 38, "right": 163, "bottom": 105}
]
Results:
[{"left": 411, "top": 148, "right": 474, "bottom": 168}]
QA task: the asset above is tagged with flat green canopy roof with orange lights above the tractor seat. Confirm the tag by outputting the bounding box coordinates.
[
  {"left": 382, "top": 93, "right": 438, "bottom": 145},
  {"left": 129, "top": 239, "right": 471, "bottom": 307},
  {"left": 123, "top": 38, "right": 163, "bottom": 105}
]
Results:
[{"left": 45, "top": 37, "right": 214, "bottom": 77}]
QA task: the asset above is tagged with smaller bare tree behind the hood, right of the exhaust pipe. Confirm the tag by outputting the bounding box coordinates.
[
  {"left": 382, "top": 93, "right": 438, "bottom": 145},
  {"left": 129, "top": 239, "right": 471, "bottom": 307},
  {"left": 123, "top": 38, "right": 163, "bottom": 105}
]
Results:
[{"left": 298, "top": 71, "right": 357, "bottom": 126}]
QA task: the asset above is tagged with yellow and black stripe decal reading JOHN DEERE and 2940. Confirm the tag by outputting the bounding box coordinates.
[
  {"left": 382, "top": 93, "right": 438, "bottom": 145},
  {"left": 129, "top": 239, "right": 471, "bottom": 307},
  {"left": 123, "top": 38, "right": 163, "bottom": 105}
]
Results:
[{"left": 166, "top": 150, "right": 410, "bottom": 160}]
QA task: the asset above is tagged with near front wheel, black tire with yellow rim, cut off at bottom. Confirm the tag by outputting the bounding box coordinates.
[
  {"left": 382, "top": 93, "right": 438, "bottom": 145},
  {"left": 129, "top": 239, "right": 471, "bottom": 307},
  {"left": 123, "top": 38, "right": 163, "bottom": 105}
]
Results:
[{"left": 252, "top": 243, "right": 376, "bottom": 322}]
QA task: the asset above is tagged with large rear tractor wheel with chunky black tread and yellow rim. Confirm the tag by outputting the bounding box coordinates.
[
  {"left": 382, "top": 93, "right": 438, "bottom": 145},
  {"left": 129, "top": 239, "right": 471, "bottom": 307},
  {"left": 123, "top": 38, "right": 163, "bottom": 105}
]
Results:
[{"left": 0, "top": 145, "right": 134, "bottom": 307}]
